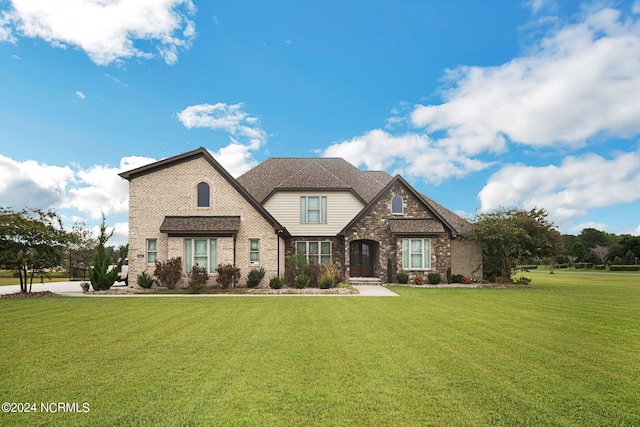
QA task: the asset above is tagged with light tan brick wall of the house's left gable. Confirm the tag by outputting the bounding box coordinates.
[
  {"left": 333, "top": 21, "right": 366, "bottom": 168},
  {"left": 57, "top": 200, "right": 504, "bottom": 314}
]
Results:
[{"left": 129, "top": 157, "right": 284, "bottom": 287}]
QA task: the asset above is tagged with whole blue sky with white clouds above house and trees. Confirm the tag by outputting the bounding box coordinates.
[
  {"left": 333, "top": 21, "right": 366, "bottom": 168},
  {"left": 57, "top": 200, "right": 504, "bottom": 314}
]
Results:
[{"left": 0, "top": 0, "right": 640, "bottom": 243}]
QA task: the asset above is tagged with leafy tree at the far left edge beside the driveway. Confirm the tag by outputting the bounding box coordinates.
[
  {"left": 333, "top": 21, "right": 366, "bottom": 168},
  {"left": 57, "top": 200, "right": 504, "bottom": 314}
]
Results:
[{"left": 0, "top": 206, "right": 69, "bottom": 293}]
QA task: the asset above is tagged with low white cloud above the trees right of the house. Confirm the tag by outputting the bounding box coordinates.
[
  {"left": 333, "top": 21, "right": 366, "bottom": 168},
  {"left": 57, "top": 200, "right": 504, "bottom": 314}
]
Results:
[{"left": 478, "top": 151, "right": 640, "bottom": 231}]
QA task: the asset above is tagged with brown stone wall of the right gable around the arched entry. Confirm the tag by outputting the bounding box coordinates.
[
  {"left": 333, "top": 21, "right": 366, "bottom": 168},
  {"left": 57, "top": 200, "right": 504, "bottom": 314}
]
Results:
[{"left": 344, "top": 182, "right": 451, "bottom": 282}]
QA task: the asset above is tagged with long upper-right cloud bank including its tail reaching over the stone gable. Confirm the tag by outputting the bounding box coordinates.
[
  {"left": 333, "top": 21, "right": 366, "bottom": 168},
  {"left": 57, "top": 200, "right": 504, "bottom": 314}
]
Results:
[{"left": 323, "top": 5, "right": 640, "bottom": 183}]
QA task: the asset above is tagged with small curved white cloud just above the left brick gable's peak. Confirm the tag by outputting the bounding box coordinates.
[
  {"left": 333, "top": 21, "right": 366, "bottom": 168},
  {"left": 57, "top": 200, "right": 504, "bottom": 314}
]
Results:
[{"left": 177, "top": 102, "right": 267, "bottom": 176}]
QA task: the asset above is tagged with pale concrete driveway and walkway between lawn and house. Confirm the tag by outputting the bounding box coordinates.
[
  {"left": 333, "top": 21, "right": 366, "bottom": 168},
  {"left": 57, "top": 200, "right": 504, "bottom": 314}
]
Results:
[{"left": 0, "top": 282, "right": 399, "bottom": 297}]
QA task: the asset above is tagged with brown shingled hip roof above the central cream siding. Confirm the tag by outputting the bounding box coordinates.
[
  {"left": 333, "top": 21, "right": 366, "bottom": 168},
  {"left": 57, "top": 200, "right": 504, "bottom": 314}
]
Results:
[{"left": 237, "top": 157, "right": 393, "bottom": 203}]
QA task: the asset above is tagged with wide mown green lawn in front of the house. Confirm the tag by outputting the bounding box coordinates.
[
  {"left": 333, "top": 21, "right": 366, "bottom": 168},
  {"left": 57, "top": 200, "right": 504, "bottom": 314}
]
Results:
[{"left": 0, "top": 272, "right": 640, "bottom": 426}]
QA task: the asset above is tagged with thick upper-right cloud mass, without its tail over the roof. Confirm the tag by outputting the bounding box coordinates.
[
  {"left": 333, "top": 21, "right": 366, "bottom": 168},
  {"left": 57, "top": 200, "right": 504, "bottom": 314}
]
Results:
[{"left": 411, "top": 9, "right": 640, "bottom": 155}]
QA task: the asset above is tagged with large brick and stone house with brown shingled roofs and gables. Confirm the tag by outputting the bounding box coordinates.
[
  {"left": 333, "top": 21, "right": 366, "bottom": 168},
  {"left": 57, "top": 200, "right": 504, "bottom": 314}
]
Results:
[{"left": 120, "top": 148, "right": 482, "bottom": 286}]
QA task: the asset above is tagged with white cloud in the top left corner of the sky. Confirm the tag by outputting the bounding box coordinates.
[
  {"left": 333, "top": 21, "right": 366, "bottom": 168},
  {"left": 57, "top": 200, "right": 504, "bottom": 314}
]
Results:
[{"left": 0, "top": 0, "right": 196, "bottom": 65}]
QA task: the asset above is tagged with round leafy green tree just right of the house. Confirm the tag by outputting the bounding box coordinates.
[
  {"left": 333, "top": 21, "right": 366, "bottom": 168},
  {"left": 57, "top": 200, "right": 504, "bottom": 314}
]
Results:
[{"left": 469, "top": 208, "right": 564, "bottom": 278}]
